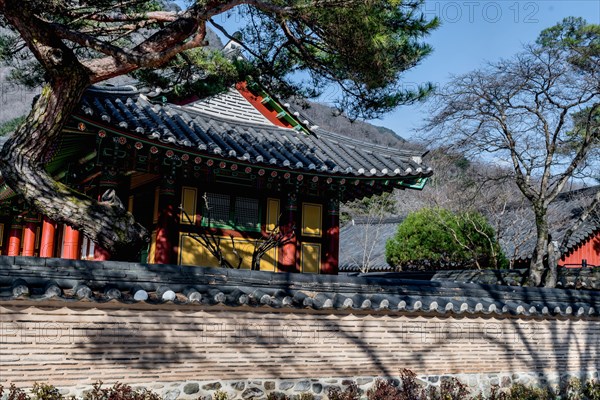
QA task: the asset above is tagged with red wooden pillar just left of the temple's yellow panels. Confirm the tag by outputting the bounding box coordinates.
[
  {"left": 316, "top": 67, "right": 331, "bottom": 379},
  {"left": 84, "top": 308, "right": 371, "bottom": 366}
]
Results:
[{"left": 154, "top": 178, "right": 177, "bottom": 264}]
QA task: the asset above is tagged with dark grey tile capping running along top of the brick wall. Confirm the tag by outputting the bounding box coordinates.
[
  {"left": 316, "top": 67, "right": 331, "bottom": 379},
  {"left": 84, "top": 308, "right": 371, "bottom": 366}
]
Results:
[{"left": 0, "top": 256, "right": 600, "bottom": 318}]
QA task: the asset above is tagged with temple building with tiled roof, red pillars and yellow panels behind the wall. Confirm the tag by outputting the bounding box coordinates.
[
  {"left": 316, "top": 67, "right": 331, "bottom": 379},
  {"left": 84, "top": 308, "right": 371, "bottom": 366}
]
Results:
[{"left": 0, "top": 83, "right": 432, "bottom": 274}]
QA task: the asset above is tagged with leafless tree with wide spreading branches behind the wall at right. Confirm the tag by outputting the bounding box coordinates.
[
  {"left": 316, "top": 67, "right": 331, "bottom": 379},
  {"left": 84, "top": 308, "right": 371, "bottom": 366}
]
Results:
[{"left": 424, "top": 18, "right": 600, "bottom": 286}]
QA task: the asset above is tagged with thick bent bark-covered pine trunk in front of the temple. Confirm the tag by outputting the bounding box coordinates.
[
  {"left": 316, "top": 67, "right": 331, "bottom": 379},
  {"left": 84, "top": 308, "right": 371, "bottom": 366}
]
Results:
[{"left": 0, "top": 69, "right": 149, "bottom": 259}]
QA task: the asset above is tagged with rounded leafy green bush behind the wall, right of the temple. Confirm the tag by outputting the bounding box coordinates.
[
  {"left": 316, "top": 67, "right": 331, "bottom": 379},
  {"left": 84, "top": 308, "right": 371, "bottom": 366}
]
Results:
[{"left": 385, "top": 208, "right": 506, "bottom": 270}]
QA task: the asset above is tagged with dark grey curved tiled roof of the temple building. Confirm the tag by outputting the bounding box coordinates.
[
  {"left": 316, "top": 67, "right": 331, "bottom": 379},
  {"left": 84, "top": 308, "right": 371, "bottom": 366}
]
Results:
[{"left": 80, "top": 87, "right": 431, "bottom": 180}]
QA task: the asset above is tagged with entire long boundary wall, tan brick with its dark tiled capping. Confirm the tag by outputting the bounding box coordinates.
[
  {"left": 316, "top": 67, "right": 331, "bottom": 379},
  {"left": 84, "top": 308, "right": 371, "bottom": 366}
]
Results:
[{"left": 0, "top": 257, "right": 600, "bottom": 394}]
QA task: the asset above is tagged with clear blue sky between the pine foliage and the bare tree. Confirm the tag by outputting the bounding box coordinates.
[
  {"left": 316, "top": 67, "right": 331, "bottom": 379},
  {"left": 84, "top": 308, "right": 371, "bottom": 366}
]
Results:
[{"left": 371, "top": 0, "right": 600, "bottom": 139}]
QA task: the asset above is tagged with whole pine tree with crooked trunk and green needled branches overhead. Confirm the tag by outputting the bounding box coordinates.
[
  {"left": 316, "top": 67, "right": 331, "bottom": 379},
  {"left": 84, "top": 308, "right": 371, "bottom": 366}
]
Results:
[{"left": 0, "top": 0, "right": 437, "bottom": 258}]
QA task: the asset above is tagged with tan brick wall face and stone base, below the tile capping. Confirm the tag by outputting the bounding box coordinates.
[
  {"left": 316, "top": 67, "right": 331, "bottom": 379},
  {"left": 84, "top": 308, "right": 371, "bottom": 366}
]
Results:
[{"left": 0, "top": 300, "right": 600, "bottom": 399}]
